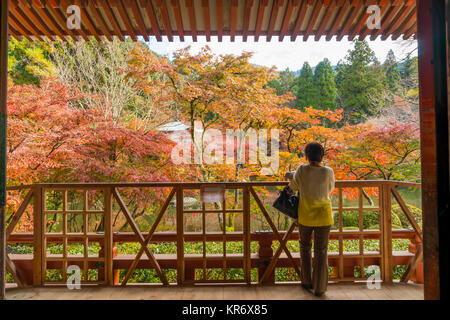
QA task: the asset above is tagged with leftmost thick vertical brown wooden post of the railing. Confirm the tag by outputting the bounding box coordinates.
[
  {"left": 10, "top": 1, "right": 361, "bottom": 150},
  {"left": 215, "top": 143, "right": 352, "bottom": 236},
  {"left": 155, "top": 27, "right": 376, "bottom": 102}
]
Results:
[{"left": 32, "top": 185, "right": 45, "bottom": 286}]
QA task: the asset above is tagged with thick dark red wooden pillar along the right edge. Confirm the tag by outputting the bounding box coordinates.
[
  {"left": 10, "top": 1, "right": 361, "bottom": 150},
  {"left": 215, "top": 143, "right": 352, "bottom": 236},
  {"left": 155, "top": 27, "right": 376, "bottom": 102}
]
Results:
[{"left": 417, "top": 0, "right": 449, "bottom": 299}]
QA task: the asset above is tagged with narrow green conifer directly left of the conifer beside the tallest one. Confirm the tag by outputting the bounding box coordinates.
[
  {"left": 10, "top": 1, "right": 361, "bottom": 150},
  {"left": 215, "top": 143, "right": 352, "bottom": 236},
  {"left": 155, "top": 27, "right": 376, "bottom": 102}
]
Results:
[{"left": 296, "top": 62, "right": 318, "bottom": 109}]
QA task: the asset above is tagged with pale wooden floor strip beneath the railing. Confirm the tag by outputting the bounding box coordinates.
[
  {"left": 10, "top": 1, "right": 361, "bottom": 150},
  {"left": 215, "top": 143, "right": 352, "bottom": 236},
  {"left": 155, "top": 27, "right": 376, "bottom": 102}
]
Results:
[{"left": 6, "top": 283, "right": 423, "bottom": 300}]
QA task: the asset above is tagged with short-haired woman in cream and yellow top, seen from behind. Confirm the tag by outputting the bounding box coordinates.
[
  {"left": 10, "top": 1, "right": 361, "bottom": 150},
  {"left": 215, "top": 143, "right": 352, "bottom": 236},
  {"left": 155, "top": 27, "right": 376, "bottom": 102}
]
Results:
[{"left": 287, "top": 142, "right": 335, "bottom": 297}]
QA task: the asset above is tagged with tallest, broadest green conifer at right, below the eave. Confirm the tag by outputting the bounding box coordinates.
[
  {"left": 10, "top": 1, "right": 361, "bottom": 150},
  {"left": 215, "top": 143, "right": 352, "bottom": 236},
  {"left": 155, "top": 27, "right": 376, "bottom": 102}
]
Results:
[{"left": 335, "top": 41, "right": 385, "bottom": 124}]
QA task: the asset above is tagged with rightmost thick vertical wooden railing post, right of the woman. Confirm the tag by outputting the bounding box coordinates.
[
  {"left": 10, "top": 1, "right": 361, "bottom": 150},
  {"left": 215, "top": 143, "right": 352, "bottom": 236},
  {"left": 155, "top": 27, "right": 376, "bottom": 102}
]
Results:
[{"left": 380, "top": 182, "right": 392, "bottom": 282}]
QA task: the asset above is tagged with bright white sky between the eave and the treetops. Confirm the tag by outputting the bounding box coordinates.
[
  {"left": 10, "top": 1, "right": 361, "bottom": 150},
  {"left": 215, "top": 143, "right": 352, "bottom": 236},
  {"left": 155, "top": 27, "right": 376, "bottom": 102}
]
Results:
[{"left": 147, "top": 36, "right": 417, "bottom": 71}]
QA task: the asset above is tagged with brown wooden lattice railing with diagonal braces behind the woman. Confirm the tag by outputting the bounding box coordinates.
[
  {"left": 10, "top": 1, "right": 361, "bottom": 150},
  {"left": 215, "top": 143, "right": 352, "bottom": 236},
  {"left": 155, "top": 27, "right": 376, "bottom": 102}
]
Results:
[{"left": 6, "top": 181, "right": 422, "bottom": 286}]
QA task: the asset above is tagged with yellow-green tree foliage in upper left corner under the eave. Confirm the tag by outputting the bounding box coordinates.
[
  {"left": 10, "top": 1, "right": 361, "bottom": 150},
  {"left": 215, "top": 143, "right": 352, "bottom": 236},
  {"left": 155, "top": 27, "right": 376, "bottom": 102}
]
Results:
[{"left": 8, "top": 38, "right": 54, "bottom": 86}]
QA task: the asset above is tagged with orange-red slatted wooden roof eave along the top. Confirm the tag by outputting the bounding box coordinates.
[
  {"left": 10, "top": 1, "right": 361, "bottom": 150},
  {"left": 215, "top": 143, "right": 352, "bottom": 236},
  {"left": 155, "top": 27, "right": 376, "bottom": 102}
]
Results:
[{"left": 9, "top": 0, "right": 417, "bottom": 41}]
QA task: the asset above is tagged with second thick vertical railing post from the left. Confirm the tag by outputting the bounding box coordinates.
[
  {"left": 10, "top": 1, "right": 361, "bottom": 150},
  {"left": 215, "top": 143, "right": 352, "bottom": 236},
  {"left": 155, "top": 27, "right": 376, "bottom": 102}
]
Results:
[{"left": 104, "top": 188, "right": 114, "bottom": 286}]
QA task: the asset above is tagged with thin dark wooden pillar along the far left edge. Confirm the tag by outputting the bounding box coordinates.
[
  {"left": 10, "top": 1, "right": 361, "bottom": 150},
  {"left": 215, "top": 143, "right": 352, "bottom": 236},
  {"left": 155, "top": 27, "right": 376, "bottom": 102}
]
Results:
[{"left": 0, "top": 0, "right": 9, "bottom": 300}]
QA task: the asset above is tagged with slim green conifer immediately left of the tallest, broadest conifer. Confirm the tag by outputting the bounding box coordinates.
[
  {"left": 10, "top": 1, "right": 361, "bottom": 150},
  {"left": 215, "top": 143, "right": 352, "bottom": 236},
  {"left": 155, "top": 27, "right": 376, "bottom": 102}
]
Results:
[{"left": 314, "top": 58, "right": 337, "bottom": 110}]
